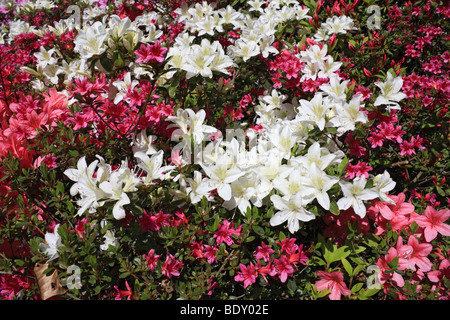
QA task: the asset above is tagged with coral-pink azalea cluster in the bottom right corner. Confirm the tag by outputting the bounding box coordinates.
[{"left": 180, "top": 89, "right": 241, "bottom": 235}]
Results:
[{"left": 368, "top": 193, "right": 450, "bottom": 298}]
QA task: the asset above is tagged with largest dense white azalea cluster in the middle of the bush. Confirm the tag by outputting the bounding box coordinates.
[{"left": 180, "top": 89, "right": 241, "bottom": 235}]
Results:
[{"left": 163, "top": 92, "right": 395, "bottom": 232}]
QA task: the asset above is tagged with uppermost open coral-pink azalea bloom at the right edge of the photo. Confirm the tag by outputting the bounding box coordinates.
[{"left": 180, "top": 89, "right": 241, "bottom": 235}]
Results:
[{"left": 415, "top": 206, "right": 450, "bottom": 242}]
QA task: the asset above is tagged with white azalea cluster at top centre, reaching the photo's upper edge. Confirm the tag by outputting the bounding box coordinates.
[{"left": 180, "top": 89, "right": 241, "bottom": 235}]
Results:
[{"left": 168, "top": 1, "right": 309, "bottom": 79}]
